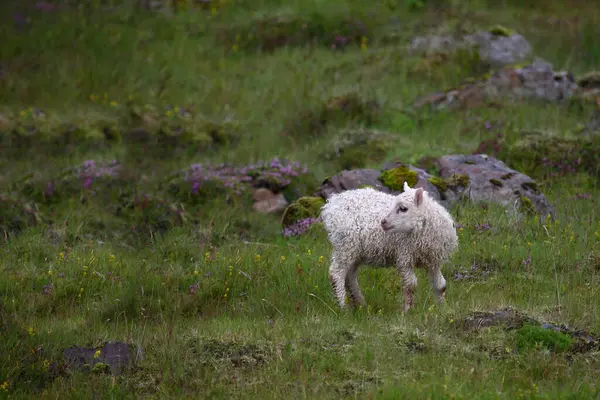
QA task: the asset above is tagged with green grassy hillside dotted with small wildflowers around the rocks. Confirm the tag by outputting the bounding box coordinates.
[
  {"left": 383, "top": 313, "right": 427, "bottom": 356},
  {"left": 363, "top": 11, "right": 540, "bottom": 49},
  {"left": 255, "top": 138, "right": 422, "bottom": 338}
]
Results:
[{"left": 0, "top": 0, "right": 600, "bottom": 399}]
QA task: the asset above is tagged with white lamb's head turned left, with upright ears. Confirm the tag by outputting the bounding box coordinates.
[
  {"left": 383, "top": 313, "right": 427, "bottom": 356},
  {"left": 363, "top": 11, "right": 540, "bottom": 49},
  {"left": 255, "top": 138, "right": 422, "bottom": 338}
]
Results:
[{"left": 381, "top": 182, "right": 427, "bottom": 233}]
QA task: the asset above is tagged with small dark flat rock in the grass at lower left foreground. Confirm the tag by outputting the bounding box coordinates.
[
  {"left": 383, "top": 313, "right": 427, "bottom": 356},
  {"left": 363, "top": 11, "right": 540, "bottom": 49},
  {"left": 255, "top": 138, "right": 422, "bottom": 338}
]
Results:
[{"left": 63, "top": 342, "right": 133, "bottom": 375}]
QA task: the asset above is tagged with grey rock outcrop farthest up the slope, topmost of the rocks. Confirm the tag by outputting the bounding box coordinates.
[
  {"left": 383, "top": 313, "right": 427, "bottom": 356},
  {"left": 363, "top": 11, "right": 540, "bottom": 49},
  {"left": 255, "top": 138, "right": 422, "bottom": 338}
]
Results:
[{"left": 408, "top": 27, "right": 532, "bottom": 68}]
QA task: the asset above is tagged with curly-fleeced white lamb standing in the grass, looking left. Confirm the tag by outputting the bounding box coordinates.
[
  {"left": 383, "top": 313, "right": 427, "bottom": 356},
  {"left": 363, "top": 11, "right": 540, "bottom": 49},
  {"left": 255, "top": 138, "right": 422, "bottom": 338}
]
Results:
[{"left": 321, "top": 182, "right": 458, "bottom": 312}]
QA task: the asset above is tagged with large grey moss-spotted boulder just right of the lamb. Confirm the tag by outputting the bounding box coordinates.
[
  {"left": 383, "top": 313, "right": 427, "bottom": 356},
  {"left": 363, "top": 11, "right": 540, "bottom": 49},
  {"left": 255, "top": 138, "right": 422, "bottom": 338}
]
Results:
[{"left": 437, "top": 154, "right": 554, "bottom": 216}]
